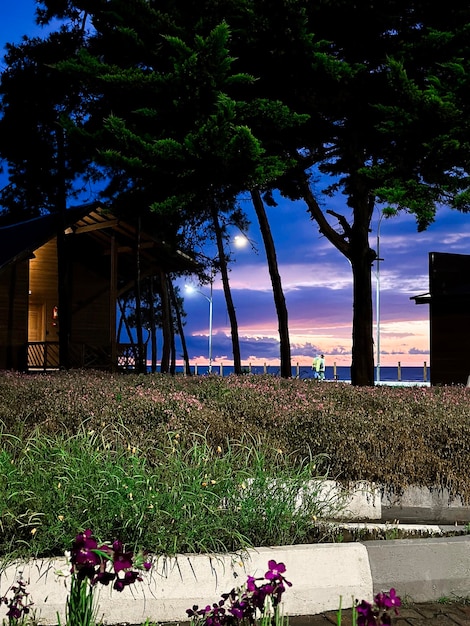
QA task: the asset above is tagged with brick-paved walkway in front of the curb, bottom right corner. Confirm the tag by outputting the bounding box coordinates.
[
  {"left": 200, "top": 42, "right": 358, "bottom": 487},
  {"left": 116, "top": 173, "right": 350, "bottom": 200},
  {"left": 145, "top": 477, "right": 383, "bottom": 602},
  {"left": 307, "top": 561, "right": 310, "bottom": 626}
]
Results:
[{"left": 290, "top": 602, "right": 470, "bottom": 626}]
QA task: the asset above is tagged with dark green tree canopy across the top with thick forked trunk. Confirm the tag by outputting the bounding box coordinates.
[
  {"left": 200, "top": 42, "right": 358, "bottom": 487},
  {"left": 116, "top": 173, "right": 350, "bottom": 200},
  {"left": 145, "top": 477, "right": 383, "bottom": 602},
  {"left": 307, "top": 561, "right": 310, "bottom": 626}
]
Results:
[{"left": 2, "top": 0, "right": 470, "bottom": 385}]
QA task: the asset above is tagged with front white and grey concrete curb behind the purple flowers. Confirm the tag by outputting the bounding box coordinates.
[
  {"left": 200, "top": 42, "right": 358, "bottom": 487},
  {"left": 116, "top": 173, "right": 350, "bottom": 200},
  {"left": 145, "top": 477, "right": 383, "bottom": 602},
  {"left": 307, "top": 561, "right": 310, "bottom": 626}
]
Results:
[{"left": 0, "top": 536, "right": 470, "bottom": 625}]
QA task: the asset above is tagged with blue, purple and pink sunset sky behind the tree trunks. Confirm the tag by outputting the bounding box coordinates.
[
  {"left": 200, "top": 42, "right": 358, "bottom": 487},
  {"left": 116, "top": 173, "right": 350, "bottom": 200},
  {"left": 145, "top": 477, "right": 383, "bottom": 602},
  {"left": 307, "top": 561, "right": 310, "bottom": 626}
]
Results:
[{"left": 0, "top": 0, "right": 470, "bottom": 366}]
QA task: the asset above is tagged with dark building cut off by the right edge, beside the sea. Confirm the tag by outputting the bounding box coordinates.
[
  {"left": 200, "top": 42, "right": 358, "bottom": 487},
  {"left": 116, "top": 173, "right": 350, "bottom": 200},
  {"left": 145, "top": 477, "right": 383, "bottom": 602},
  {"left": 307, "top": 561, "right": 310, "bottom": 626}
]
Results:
[{"left": 412, "top": 252, "right": 470, "bottom": 385}]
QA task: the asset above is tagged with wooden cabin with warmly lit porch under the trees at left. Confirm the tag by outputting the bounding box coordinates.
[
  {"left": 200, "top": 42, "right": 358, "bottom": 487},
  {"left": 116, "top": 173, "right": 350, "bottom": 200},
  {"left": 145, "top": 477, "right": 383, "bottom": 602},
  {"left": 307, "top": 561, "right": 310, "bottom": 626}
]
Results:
[{"left": 0, "top": 203, "right": 194, "bottom": 371}]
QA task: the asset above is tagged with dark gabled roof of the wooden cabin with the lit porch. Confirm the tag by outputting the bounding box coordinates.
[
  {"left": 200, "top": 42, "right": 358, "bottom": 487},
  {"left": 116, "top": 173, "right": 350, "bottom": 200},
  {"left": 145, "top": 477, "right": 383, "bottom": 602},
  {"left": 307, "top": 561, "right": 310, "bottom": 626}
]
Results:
[{"left": 0, "top": 202, "right": 198, "bottom": 271}]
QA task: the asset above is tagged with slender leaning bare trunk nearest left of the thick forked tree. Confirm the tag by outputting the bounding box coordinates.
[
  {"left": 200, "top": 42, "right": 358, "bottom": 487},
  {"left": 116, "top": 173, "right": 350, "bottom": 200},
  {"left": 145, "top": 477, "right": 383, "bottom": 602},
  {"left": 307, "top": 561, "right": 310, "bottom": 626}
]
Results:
[{"left": 251, "top": 189, "right": 292, "bottom": 378}]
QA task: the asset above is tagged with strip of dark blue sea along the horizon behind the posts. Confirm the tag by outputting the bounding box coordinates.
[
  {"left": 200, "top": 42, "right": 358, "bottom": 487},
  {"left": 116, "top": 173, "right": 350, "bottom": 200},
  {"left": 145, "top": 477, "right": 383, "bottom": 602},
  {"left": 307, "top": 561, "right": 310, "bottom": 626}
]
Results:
[{"left": 152, "top": 363, "right": 430, "bottom": 385}]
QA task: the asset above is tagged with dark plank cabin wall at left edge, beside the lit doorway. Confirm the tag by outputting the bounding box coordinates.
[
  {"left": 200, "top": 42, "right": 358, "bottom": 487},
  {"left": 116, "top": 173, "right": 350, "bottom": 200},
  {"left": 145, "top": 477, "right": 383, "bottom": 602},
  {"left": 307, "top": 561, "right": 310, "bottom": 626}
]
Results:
[{"left": 0, "top": 260, "right": 28, "bottom": 371}]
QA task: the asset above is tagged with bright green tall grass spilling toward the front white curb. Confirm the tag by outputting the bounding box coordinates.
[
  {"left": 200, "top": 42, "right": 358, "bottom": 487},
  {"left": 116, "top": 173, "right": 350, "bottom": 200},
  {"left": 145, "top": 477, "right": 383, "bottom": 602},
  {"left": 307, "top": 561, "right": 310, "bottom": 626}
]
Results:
[{"left": 0, "top": 430, "right": 339, "bottom": 556}]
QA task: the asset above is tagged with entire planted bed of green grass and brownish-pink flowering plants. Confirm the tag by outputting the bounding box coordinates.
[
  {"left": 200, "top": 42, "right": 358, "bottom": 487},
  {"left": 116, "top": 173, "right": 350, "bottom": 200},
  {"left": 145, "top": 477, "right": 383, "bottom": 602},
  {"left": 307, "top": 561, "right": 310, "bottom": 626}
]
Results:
[{"left": 0, "top": 371, "right": 470, "bottom": 556}]
